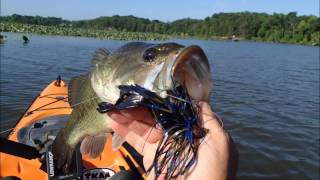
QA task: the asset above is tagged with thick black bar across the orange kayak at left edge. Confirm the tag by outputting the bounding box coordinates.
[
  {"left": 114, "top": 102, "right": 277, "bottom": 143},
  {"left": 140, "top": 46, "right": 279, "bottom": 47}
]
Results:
[{"left": 0, "top": 138, "right": 41, "bottom": 159}]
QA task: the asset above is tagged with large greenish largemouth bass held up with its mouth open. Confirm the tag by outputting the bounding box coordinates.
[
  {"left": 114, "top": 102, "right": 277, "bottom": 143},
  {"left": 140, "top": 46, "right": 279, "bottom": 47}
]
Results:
[{"left": 53, "top": 42, "right": 211, "bottom": 172}]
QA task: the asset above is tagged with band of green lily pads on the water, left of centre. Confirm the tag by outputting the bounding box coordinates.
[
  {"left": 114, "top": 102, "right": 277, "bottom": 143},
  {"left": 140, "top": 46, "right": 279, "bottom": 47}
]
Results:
[{"left": 0, "top": 22, "right": 172, "bottom": 41}]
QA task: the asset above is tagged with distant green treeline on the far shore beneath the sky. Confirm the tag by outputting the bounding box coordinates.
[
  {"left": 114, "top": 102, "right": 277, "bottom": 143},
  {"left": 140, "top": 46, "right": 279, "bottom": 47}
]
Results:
[{"left": 0, "top": 12, "right": 320, "bottom": 45}]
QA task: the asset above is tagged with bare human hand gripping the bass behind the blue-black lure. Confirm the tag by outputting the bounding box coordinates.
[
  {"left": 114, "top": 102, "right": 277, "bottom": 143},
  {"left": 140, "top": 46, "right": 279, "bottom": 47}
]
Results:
[{"left": 109, "top": 102, "right": 238, "bottom": 180}]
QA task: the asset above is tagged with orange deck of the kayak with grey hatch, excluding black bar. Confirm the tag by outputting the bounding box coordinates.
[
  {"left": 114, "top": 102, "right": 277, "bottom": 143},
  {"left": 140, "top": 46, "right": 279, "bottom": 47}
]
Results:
[{"left": 0, "top": 81, "right": 146, "bottom": 179}]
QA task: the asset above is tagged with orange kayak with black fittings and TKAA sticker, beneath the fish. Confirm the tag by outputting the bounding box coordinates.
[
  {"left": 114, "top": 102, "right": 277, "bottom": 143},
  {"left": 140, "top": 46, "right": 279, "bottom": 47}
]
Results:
[{"left": 0, "top": 78, "right": 146, "bottom": 179}]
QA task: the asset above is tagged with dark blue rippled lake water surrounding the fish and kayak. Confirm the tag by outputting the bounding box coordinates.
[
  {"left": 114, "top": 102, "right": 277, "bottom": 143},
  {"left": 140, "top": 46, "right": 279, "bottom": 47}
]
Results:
[{"left": 0, "top": 33, "right": 320, "bottom": 179}]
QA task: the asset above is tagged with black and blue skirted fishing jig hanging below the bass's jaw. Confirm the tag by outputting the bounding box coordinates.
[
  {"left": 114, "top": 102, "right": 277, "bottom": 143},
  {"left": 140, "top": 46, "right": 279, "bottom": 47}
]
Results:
[{"left": 97, "top": 84, "right": 208, "bottom": 179}]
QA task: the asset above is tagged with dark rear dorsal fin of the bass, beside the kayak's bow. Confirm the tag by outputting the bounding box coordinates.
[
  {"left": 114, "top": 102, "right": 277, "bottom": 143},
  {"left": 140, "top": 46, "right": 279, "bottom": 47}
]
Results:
[{"left": 68, "top": 74, "right": 89, "bottom": 106}]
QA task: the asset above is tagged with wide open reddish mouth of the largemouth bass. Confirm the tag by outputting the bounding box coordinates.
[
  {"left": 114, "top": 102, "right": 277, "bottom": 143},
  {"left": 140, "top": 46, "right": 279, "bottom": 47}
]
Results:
[{"left": 171, "top": 45, "right": 211, "bottom": 101}]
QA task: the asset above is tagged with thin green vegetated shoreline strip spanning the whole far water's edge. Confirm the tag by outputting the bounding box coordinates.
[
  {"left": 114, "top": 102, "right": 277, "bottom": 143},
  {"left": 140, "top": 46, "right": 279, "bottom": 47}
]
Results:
[{"left": 0, "top": 22, "right": 320, "bottom": 47}]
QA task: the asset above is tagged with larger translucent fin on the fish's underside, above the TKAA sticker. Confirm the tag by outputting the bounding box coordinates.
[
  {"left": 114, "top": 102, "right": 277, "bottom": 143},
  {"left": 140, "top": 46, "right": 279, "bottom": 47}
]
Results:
[{"left": 80, "top": 133, "right": 107, "bottom": 159}]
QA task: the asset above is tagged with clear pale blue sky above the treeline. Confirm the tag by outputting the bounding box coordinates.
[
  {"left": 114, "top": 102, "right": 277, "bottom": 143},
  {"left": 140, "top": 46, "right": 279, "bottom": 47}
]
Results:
[{"left": 0, "top": 0, "right": 320, "bottom": 21}]
